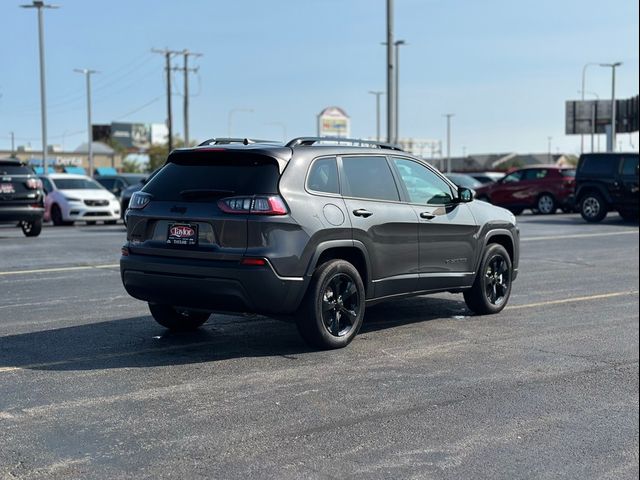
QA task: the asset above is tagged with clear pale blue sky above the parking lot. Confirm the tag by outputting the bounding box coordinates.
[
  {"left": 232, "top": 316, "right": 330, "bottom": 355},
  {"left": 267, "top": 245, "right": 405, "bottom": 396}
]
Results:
[{"left": 0, "top": 0, "right": 639, "bottom": 155}]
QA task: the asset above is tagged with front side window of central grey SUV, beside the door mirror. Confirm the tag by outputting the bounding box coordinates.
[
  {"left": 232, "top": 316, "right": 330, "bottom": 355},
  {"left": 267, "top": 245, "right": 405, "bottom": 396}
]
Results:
[{"left": 393, "top": 158, "right": 453, "bottom": 205}]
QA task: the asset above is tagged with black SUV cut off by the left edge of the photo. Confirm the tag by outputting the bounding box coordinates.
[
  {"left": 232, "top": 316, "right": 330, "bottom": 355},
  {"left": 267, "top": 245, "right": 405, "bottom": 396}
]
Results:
[{"left": 0, "top": 159, "right": 44, "bottom": 237}]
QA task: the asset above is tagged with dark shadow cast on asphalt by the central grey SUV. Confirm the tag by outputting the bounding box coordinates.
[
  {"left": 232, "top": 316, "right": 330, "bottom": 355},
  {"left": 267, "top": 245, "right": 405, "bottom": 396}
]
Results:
[{"left": 0, "top": 297, "right": 471, "bottom": 371}]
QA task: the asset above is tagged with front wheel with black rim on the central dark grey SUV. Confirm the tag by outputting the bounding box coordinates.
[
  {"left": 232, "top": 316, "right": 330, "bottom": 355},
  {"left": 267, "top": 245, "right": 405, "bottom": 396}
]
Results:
[{"left": 464, "top": 243, "right": 513, "bottom": 315}]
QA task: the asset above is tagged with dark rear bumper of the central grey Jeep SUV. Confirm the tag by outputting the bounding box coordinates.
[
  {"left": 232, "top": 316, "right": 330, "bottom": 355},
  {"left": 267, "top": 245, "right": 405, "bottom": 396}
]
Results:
[{"left": 120, "top": 253, "right": 308, "bottom": 315}]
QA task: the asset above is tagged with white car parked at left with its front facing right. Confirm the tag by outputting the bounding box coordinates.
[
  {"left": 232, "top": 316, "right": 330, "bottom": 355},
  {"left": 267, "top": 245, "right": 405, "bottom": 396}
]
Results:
[{"left": 40, "top": 173, "right": 120, "bottom": 225}]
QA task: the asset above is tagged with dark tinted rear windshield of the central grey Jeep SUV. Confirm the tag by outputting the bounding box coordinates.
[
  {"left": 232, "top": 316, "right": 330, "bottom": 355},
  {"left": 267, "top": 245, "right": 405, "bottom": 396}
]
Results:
[{"left": 148, "top": 153, "right": 280, "bottom": 202}]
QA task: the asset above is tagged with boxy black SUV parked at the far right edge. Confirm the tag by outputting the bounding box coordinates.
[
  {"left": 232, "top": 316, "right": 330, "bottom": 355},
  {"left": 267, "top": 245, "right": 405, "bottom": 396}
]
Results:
[{"left": 576, "top": 153, "right": 638, "bottom": 222}]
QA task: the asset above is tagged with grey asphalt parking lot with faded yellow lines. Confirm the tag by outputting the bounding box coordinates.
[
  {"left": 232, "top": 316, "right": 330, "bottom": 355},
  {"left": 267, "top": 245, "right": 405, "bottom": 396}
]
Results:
[{"left": 0, "top": 214, "right": 639, "bottom": 479}]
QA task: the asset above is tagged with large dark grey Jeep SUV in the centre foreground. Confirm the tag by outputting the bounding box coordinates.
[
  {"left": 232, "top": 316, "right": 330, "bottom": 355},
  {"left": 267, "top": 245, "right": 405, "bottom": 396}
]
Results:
[{"left": 120, "top": 138, "right": 519, "bottom": 348}]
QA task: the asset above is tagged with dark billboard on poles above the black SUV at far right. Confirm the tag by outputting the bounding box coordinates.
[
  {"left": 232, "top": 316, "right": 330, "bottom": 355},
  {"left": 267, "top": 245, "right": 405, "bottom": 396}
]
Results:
[{"left": 565, "top": 95, "right": 638, "bottom": 135}]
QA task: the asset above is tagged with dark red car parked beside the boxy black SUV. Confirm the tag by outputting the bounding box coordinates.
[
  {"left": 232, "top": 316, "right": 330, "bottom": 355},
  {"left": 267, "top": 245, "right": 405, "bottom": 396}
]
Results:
[{"left": 476, "top": 165, "right": 576, "bottom": 215}]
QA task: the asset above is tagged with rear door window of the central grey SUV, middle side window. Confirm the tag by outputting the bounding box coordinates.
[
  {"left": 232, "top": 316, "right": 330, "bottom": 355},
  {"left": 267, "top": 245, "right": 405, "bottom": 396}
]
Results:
[{"left": 342, "top": 157, "right": 400, "bottom": 201}]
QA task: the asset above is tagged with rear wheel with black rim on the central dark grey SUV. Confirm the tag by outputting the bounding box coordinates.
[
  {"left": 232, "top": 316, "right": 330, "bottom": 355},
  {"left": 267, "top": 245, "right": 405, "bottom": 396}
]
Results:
[{"left": 296, "top": 260, "right": 365, "bottom": 350}]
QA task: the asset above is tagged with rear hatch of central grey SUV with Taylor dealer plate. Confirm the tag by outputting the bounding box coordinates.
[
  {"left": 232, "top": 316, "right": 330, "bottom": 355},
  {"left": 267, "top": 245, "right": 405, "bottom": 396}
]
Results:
[{"left": 127, "top": 148, "right": 287, "bottom": 261}]
